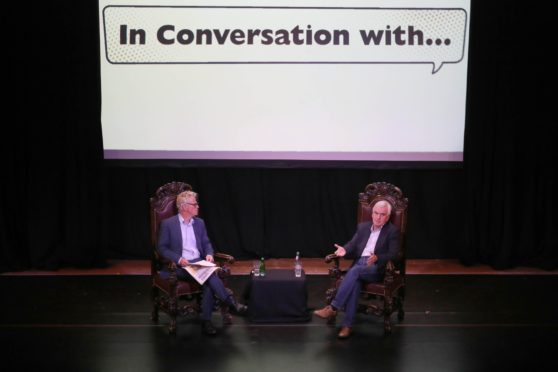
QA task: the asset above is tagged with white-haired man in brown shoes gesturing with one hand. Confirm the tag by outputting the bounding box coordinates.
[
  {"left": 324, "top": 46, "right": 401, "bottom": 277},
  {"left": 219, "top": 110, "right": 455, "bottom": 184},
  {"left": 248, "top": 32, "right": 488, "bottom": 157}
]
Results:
[{"left": 314, "top": 200, "right": 400, "bottom": 339}]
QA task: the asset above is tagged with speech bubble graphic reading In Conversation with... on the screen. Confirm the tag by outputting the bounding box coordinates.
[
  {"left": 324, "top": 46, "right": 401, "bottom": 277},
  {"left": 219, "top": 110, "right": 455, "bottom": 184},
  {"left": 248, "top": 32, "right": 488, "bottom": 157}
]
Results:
[{"left": 102, "top": 5, "right": 467, "bottom": 74}]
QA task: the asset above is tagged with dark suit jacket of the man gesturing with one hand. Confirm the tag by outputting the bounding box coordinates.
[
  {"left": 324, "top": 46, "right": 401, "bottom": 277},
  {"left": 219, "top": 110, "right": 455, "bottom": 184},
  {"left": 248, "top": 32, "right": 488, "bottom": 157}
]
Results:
[{"left": 345, "top": 221, "right": 401, "bottom": 270}]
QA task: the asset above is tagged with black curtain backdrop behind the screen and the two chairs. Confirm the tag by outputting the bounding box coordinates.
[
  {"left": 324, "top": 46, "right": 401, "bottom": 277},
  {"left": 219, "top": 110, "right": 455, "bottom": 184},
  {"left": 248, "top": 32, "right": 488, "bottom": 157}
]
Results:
[{"left": 0, "top": 0, "right": 558, "bottom": 272}]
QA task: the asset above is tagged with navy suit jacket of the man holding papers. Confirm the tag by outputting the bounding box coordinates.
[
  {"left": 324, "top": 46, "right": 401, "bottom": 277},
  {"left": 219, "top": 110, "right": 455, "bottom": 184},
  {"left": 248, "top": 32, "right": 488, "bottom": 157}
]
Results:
[{"left": 157, "top": 215, "right": 217, "bottom": 263}]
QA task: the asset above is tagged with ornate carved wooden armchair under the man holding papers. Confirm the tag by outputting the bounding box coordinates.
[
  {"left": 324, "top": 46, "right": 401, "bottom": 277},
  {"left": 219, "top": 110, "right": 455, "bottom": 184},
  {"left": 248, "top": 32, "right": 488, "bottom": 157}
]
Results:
[{"left": 150, "top": 182, "right": 234, "bottom": 334}]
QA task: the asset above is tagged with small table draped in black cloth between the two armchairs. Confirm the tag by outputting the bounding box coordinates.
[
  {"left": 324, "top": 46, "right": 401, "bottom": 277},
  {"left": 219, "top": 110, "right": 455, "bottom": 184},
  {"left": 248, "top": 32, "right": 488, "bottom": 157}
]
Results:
[{"left": 248, "top": 269, "right": 310, "bottom": 323}]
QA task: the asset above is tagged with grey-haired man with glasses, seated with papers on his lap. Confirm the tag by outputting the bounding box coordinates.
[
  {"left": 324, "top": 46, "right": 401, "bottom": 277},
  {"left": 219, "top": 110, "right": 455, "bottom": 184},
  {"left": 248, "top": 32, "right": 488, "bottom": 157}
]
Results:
[{"left": 157, "top": 191, "right": 247, "bottom": 335}]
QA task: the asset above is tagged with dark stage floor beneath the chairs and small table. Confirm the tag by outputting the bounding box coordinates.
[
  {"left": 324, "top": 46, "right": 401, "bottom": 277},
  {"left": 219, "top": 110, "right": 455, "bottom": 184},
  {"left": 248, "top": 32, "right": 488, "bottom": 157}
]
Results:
[{"left": 0, "top": 274, "right": 558, "bottom": 372}]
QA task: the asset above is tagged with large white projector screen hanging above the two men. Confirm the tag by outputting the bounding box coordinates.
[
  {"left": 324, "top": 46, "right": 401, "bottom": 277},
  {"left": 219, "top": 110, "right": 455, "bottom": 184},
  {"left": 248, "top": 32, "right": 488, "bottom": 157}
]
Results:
[{"left": 99, "top": 0, "right": 470, "bottom": 162}]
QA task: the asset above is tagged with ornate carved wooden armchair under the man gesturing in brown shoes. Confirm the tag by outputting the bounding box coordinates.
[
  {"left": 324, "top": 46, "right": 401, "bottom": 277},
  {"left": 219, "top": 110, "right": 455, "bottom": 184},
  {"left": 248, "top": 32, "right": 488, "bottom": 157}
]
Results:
[{"left": 325, "top": 182, "right": 408, "bottom": 333}]
